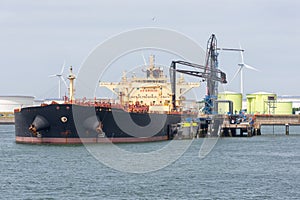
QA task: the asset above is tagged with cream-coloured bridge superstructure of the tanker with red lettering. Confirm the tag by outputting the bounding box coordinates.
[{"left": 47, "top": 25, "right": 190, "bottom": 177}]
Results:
[{"left": 99, "top": 56, "right": 200, "bottom": 107}]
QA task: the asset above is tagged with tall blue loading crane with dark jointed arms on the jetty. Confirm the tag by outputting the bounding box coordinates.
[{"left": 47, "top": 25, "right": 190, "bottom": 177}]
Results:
[{"left": 170, "top": 34, "right": 244, "bottom": 114}]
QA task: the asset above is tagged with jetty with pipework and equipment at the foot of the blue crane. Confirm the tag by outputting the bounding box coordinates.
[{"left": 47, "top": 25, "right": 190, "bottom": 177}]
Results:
[{"left": 175, "top": 114, "right": 300, "bottom": 139}]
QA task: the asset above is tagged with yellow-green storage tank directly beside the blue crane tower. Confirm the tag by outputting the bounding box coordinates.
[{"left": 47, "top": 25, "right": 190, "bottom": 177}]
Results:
[{"left": 218, "top": 91, "right": 242, "bottom": 114}]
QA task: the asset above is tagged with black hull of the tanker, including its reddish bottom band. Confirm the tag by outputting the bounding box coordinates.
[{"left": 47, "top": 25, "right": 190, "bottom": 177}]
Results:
[{"left": 15, "top": 103, "right": 181, "bottom": 144}]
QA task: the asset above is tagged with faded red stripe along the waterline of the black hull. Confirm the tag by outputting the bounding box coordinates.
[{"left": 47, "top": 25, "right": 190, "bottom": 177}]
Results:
[{"left": 16, "top": 136, "right": 168, "bottom": 144}]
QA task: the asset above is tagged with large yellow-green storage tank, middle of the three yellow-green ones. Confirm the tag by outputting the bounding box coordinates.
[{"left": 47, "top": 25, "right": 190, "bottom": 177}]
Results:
[{"left": 246, "top": 92, "right": 277, "bottom": 114}]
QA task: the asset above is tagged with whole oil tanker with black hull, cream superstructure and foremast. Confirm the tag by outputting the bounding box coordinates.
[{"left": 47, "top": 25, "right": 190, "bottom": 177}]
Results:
[{"left": 14, "top": 56, "right": 200, "bottom": 144}]
